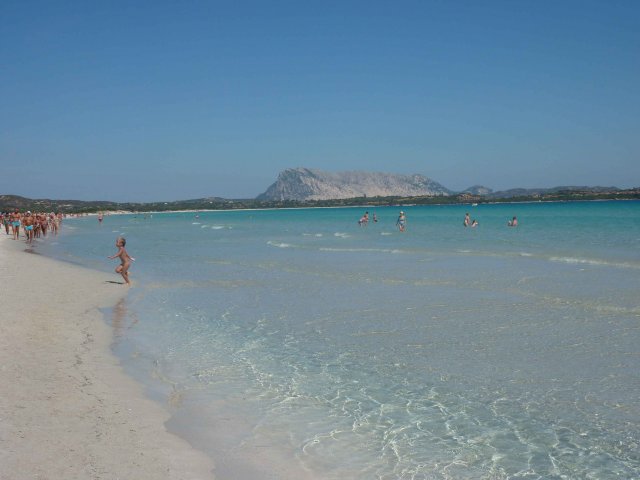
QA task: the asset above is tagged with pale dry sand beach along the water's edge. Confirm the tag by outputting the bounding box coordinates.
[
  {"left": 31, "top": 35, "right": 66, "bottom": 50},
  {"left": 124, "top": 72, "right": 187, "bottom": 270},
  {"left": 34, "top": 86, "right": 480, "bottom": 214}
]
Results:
[{"left": 0, "top": 234, "right": 214, "bottom": 480}]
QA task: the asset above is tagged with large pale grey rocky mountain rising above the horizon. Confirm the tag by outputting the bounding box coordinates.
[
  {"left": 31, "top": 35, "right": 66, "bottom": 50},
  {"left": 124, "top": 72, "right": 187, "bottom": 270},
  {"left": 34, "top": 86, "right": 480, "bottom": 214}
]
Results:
[{"left": 256, "top": 168, "right": 451, "bottom": 201}]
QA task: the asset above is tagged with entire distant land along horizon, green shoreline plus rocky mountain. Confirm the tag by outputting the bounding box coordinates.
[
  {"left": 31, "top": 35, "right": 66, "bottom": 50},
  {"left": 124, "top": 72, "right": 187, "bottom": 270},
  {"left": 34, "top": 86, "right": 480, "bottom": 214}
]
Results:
[{"left": 0, "top": 168, "right": 640, "bottom": 213}]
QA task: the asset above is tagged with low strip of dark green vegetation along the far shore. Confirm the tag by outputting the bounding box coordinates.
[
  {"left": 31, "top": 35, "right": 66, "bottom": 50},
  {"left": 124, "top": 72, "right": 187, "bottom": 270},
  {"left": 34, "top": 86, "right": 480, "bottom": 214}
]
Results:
[{"left": 0, "top": 188, "right": 640, "bottom": 213}]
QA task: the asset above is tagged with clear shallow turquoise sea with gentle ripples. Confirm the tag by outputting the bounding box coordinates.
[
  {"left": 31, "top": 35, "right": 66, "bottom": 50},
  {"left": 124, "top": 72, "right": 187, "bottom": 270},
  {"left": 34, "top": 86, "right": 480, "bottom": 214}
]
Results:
[{"left": 40, "top": 201, "right": 640, "bottom": 480}]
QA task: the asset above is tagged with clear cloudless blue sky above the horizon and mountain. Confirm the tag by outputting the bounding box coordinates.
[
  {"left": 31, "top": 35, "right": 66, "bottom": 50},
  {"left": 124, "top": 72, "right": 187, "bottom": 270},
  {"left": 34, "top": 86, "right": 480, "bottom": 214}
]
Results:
[{"left": 0, "top": 0, "right": 640, "bottom": 202}]
